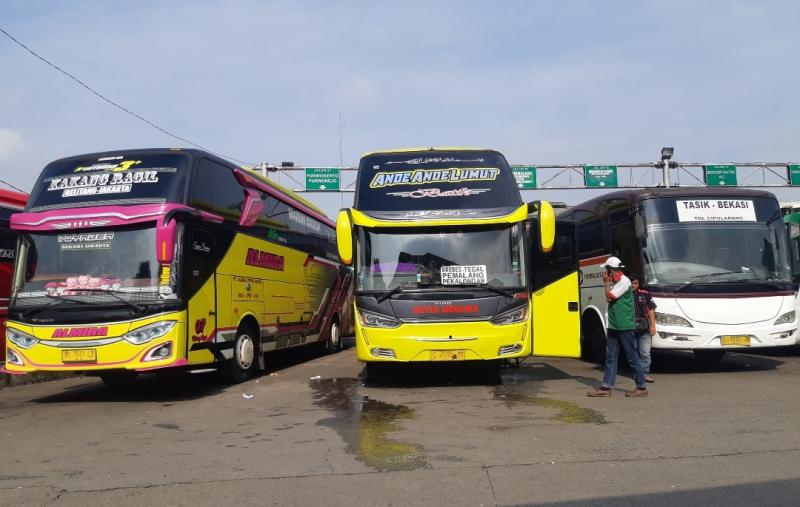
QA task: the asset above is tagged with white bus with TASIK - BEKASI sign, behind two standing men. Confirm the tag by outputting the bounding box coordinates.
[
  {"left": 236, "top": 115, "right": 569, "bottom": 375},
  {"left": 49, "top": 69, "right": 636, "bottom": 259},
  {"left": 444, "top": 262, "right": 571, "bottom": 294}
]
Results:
[{"left": 558, "top": 189, "right": 798, "bottom": 362}]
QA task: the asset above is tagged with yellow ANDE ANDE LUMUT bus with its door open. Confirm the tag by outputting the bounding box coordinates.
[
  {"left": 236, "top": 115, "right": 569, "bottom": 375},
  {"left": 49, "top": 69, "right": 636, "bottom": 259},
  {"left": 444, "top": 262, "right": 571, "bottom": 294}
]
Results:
[{"left": 336, "top": 148, "right": 580, "bottom": 369}]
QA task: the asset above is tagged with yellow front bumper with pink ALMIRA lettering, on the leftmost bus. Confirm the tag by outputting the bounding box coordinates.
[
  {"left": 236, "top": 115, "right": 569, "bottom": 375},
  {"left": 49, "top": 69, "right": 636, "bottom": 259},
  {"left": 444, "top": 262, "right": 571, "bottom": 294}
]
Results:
[{"left": 5, "top": 312, "right": 187, "bottom": 373}]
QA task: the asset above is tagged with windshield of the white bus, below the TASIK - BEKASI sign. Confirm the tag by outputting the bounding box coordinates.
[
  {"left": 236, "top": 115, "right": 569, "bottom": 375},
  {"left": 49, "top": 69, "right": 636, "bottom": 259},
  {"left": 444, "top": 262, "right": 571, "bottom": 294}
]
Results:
[{"left": 643, "top": 222, "right": 791, "bottom": 284}]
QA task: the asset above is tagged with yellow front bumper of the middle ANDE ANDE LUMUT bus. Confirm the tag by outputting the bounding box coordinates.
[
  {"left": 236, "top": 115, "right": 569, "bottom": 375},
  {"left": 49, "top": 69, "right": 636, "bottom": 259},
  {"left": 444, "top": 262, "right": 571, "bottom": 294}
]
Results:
[{"left": 356, "top": 321, "right": 531, "bottom": 362}]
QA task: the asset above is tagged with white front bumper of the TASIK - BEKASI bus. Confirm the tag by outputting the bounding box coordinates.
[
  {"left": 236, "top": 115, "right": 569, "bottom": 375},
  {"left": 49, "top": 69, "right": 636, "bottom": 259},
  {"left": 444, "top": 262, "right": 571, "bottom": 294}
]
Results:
[{"left": 652, "top": 322, "right": 798, "bottom": 350}]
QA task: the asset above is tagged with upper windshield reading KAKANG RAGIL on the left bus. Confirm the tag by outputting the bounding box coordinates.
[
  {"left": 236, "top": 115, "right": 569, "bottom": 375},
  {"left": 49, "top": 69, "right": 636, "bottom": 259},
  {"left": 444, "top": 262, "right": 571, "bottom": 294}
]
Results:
[{"left": 28, "top": 153, "right": 188, "bottom": 211}]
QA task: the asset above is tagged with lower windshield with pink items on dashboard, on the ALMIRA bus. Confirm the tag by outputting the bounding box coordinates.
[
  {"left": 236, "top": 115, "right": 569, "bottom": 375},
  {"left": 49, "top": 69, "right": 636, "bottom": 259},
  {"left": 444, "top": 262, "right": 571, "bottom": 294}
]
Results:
[{"left": 12, "top": 226, "right": 175, "bottom": 310}]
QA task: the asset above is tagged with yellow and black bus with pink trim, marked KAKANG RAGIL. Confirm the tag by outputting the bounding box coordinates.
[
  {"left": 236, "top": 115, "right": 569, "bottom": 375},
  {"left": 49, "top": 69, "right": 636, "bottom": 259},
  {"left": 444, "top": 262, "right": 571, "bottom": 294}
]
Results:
[{"left": 5, "top": 149, "right": 352, "bottom": 383}]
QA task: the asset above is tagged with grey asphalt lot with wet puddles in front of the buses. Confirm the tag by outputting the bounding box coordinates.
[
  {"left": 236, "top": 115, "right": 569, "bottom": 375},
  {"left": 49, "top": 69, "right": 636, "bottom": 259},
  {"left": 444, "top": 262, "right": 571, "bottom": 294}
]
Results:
[{"left": 0, "top": 349, "right": 800, "bottom": 505}]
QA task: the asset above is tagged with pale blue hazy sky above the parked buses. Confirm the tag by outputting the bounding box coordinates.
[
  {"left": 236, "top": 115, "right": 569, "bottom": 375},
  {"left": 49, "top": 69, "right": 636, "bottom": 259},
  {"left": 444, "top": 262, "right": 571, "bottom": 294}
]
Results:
[{"left": 0, "top": 0, "right": 800, "bottom": 214}]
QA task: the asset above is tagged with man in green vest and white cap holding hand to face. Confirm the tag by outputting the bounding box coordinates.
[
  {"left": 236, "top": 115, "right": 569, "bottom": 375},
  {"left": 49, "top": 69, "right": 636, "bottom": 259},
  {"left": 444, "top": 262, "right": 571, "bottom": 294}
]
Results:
[{"left": 586, "top": 257, "right": 647, "bottom": 398}]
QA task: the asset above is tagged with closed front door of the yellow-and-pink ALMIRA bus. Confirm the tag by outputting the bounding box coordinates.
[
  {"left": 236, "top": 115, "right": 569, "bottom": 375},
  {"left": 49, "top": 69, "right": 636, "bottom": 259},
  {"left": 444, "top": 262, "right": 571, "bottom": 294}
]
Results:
[{"left": 183, "top": 223, "right": 216, "bottom": 364}]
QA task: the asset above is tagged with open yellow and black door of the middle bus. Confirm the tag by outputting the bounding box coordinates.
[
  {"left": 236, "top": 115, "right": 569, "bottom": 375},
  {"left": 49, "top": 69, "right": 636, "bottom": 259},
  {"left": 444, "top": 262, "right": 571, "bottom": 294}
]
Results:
[{"left": 529, "top": 219, "right": 581, "bottom": 357}]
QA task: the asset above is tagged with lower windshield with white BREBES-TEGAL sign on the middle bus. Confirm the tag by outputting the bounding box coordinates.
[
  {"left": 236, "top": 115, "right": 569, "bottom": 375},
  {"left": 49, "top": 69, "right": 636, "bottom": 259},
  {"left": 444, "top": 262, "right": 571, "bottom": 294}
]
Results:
[{"left": 356, "top": 224, "right": 526, "bottom": 291}]
